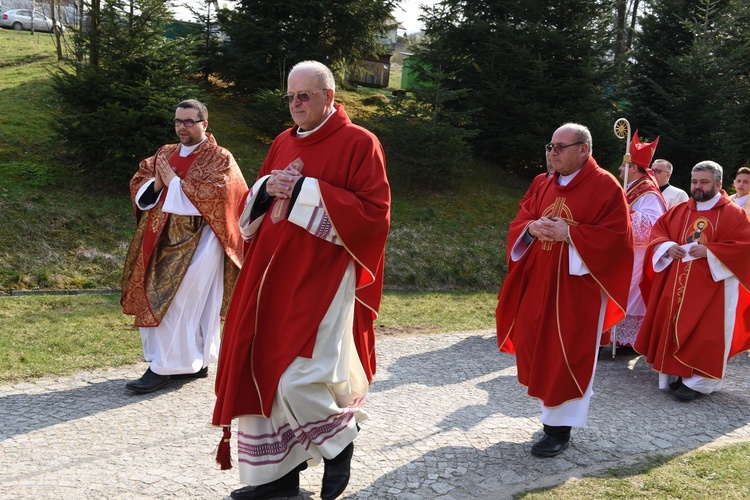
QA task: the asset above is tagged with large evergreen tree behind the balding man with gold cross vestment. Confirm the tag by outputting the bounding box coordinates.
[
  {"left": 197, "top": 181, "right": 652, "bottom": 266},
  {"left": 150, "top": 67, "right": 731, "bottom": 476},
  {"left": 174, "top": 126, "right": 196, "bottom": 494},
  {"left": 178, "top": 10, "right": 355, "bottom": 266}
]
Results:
[{"left": 418, "top": 0, "right": 617, "bottom": 178}]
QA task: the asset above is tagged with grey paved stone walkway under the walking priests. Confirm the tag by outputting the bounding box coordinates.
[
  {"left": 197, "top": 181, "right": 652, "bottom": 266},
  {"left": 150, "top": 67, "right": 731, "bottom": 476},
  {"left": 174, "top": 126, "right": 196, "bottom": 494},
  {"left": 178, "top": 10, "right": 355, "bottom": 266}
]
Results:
[{"left": 0, "top": 331, "right": 750, "bottom": 500}]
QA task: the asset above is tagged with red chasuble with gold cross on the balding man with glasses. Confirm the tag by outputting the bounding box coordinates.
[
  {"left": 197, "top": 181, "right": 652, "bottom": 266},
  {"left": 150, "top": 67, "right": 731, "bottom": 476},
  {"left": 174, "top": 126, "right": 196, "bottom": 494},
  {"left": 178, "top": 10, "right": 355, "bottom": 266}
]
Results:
[{"left": 496, "top": 158, "right": 633, "bottom": 407}]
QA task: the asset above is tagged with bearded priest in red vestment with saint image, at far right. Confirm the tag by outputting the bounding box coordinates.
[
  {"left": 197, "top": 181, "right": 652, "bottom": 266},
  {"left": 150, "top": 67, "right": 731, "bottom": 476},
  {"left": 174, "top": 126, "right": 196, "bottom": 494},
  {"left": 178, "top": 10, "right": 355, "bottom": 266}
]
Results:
[{"left": 635, "top": 161, "right": 750, "bottom": 400}]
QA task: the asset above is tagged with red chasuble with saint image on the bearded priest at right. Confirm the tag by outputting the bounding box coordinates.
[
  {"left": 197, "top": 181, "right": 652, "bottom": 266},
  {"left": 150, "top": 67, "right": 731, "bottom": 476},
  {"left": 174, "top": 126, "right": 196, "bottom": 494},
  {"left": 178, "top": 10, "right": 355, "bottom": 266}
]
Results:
[{"left": 633, "top": 191, "right": 750, "bottom": 378}]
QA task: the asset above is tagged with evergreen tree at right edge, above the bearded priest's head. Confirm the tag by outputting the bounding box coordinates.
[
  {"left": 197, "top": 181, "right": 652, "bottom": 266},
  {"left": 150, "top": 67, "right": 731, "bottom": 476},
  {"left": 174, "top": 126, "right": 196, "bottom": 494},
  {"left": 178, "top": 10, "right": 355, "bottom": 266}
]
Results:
[{"left": 629, "top": 0, "right": 750, "bottom": 188}]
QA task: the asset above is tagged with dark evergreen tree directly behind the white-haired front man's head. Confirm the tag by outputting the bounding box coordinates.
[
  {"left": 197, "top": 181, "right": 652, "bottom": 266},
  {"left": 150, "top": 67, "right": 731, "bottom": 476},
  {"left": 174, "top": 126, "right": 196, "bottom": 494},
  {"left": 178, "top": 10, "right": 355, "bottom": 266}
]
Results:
[{"left": 219, "top": 0, "right": 397, "bottom": 92}]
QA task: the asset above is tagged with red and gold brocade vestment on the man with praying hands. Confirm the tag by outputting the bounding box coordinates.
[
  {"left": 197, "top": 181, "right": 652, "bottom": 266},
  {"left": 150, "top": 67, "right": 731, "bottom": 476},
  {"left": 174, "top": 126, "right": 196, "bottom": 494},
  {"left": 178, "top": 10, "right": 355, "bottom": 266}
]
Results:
[{"left": 120, "top": 134, "right": 248, "bottom": 327}]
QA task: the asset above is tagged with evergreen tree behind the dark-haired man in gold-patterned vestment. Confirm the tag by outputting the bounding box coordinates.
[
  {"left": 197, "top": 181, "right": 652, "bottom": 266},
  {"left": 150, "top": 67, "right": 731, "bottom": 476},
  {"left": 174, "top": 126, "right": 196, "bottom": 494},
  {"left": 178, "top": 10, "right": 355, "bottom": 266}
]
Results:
[{"left": 53, "top": 0, "right": 196, "bottom": 185}]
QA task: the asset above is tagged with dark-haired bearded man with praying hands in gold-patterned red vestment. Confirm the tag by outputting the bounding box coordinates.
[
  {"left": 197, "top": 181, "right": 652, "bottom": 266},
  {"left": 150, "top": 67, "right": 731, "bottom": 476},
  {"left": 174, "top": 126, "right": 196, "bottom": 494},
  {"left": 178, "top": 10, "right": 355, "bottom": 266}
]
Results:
[{"left": 121, "top": 99, "right": 247, "bottom": 394}]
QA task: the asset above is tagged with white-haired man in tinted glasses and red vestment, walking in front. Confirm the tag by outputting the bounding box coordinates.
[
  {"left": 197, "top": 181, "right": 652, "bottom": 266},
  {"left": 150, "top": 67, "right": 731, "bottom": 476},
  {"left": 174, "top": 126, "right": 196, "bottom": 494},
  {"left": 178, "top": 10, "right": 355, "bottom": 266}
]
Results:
[{"left": 213, "top": 61, "right": 391, "bottom": 500}]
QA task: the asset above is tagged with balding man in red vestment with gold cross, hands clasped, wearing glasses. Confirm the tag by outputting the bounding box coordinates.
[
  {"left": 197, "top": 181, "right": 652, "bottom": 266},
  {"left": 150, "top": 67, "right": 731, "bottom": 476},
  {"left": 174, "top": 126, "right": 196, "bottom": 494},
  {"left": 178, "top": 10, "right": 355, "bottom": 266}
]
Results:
[{"left": 496, "top": 123, "right": 633, "bottom": 457}]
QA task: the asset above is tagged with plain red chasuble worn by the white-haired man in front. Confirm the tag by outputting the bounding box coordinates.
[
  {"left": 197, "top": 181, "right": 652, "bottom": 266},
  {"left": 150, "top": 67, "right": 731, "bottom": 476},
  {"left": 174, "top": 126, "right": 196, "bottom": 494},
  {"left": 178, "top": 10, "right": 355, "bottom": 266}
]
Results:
[{"left": 213, "top": 105, "right": 390, "bottom": 426}]
